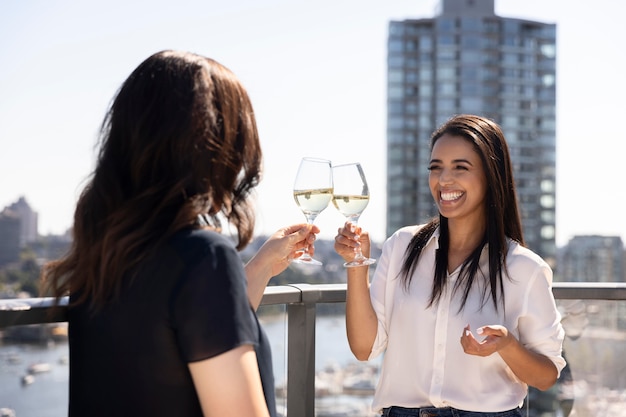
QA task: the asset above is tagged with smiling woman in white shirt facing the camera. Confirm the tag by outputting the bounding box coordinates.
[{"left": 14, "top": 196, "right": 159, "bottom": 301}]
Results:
[{"left": 335, "top": 115, "right": 565, "bottom": 417}]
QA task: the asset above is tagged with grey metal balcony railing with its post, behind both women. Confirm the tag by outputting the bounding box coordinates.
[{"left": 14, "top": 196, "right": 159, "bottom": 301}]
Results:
[{"left": 0, "top": 282, "right": 626, "bottom": 417}]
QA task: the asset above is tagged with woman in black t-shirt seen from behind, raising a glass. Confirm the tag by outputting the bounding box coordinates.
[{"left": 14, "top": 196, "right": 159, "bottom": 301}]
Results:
[{"left": 44, "top": 51, "right": 319, "bottom": 417}]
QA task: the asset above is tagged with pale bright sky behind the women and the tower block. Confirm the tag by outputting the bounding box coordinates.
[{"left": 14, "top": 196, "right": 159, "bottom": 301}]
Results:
[{"left": 0, "top": 0, "right": 626, "bottom": 245}]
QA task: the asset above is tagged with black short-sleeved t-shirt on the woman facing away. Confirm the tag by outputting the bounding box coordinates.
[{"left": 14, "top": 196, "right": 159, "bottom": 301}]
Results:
[{"left": 69, "top": 230, "right": 276, "bottom": 417}]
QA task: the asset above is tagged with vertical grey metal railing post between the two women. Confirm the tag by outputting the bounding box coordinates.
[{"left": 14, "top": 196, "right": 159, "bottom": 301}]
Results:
[{"left": 287, "top": 286, "right": 316, "bottom": 417}]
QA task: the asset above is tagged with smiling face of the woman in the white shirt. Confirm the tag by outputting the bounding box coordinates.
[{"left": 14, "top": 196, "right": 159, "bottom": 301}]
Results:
[{"left": 428, "top": 134, "right": 487, "bottom": 224}]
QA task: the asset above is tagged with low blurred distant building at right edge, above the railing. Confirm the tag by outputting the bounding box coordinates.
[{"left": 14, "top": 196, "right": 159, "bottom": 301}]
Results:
[{"left": 558, "top": 235, "right": 626, "bottom": 282}]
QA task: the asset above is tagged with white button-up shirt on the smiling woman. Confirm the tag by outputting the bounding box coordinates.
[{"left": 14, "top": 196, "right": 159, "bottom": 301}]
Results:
[{"left": 370, "top": 226, "right": 565, "bottom": 412}]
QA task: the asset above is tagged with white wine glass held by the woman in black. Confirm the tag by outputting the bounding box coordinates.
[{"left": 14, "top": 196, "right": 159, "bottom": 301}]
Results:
[{"left": 293, "top": 158, "right": 333, "bottom": 265}]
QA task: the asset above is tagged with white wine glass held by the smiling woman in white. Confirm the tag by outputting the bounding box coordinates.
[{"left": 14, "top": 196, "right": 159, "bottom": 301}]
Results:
[{"left": 333, "top": 162, "right": 376, "bottom": 268}]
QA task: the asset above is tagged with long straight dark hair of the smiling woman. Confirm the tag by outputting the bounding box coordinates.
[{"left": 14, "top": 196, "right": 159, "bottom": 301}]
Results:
[{"left": 401, "top": 115, "right": 524, "bottom": 309}]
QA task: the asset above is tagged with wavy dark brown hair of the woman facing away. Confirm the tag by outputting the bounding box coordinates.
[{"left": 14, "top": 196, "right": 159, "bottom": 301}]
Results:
[{"left": 43, "top": 51, "right": 262, "bottom": 307}]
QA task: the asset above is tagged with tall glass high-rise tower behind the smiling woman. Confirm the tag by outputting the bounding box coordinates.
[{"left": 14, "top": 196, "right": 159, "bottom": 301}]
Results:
[{"left": 387, "top": 0, "right": 556, "bottom": 262}]
